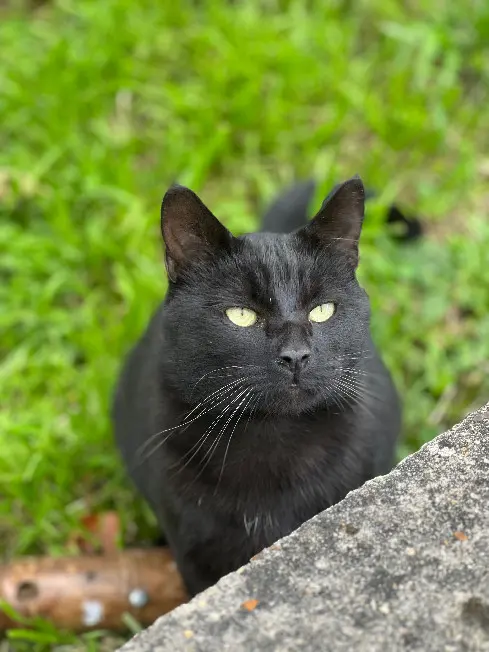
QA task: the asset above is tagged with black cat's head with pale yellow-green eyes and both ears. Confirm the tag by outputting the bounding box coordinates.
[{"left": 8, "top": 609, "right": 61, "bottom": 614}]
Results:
[{"left": 162, "top": 177, "right": 370, "bottom": 415}]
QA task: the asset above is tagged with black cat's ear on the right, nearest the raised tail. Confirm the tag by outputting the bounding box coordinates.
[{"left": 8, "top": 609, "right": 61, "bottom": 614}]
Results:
[{"left": 299, "top": 175, "right": 365, "bottom": 268}]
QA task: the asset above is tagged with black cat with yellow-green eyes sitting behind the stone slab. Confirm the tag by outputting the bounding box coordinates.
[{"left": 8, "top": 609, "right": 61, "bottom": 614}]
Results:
[{"left": 113, "top": 177, "right": 400, "bottom": 594}]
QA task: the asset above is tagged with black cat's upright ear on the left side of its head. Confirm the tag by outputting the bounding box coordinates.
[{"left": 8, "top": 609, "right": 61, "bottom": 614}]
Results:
[{"left": 161, "top": 185, "right": 233, "bottom": 282}]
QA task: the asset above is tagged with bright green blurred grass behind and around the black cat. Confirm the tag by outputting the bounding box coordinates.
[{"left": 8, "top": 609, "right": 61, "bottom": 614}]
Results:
[{"left": 0, "top": 0, "right": 489, "bottom": 650}]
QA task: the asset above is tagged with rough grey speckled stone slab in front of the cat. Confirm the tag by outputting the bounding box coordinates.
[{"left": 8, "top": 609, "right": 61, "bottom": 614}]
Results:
[{"left": 121, "top": 404, "right": 489, "bottom": 652}]
